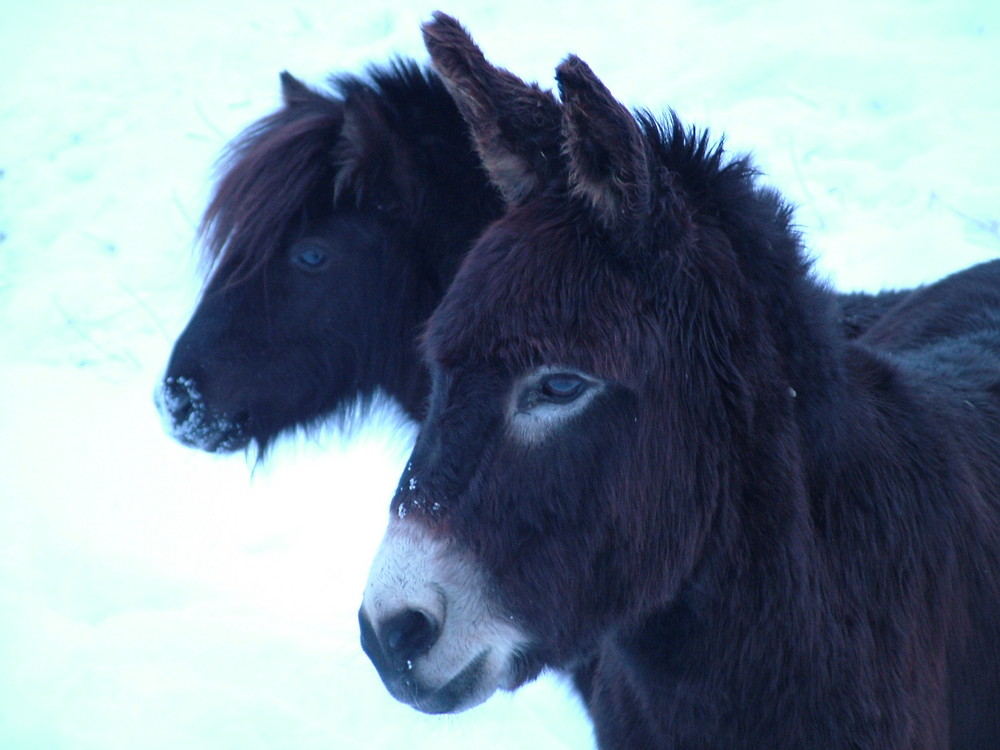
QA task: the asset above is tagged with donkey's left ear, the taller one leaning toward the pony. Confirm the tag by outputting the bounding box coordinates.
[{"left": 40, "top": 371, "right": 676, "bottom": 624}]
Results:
[{"left": 423, "top": 11, "right": 561, "bottom": 205}]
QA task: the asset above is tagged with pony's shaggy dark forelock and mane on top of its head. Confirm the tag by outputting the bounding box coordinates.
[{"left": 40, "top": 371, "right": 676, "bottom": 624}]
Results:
[{"left": 199, "top": 59, "right": 464, "bottom": 284}]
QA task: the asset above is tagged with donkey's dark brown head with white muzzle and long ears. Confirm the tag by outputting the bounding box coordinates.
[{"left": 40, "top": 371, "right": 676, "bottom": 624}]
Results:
[{"left": 361, "top": 15, "right": 816, "bottom": 712}]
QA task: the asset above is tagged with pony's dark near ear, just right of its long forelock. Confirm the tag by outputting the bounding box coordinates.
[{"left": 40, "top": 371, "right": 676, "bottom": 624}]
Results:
[{"left": 333, "top": 88, "right": 419, "bottom": 215}]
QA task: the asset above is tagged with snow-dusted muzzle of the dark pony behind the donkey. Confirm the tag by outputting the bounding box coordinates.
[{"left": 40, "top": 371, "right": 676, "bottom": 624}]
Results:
[{"left": 153, "top": 377, "right": 251, "bottom": 453}]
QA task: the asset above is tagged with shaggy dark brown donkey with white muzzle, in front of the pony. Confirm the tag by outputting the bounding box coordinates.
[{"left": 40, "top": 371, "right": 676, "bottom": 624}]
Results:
[{"left": 360, "top": 14, "right": 1000, "bottom": 750}]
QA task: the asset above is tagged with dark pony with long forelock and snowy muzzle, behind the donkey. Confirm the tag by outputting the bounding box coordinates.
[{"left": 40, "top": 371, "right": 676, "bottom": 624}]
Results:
[{"left": 157, "top": 57, "right": 905, "bottom": 451}]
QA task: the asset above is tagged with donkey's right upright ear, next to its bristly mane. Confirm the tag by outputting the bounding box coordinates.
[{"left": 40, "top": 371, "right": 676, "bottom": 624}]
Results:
[{"left": 556, "top": 55, "right": 651, "bottom": 226}]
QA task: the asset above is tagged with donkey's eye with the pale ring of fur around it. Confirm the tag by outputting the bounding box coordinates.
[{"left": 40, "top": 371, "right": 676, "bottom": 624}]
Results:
[{"left": 508, "top": 367, "right": 606, "bottom": 443}]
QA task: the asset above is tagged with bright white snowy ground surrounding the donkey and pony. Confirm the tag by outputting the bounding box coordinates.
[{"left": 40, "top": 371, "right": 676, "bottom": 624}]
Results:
[{"left": 0, "top": 0, "right": 1000, "bottom": 750}]
